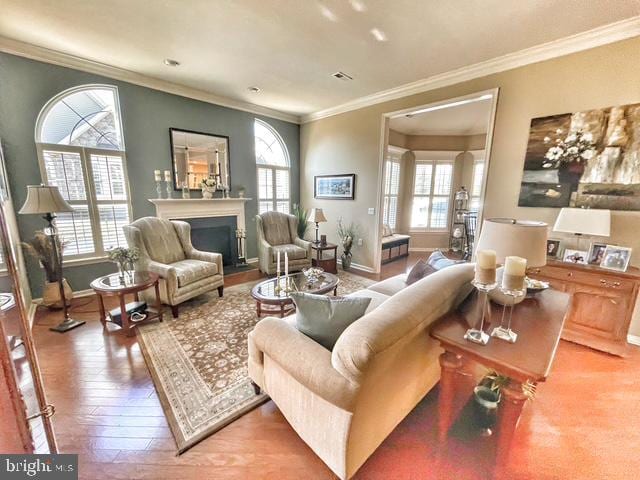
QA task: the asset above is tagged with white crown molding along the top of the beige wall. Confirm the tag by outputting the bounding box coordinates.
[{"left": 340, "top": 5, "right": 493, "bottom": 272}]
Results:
[{"left": 301, "top": 16, "right": 640, "bottom": 123}]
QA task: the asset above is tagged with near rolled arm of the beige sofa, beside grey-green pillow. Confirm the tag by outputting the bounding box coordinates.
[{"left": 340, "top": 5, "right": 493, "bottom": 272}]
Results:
[{"left": 249, "top": 317, "right": 359, "bottom": 411}]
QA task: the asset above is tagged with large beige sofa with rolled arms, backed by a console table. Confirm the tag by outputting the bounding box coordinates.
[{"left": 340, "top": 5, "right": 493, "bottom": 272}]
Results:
[{"left": 248, "top": 264, "right": 473, "bottom": 479}]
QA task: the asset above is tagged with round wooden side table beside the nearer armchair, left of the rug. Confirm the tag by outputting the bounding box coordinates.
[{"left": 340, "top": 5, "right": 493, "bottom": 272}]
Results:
[{"left": 91, "top": 271, "right": 162, "bottom": 337}]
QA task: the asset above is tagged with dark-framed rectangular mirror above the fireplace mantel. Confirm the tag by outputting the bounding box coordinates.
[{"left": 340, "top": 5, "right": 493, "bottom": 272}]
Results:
[{"left": 169, "top": 128, "right": 231, "bottom": 190}]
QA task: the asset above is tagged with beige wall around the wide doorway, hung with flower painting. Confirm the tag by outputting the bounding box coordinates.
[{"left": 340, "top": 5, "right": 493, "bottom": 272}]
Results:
[{"left": 300, "top": 37, "right": 640, "bottom": 335}]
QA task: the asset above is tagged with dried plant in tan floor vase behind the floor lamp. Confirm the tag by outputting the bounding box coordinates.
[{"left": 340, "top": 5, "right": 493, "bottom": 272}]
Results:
[{"left": 22, "top": 231, "right": 73, "bottom": 308}]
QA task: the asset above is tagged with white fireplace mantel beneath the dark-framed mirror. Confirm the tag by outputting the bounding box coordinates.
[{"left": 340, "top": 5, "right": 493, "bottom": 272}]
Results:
[{"left": 149, "top": 198, "right": 252, "bottom": 230}]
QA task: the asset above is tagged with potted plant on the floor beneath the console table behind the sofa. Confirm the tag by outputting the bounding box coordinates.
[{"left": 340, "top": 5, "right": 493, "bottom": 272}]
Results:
[{"left": 473, "top": 370, "right": 536, "bottom": 436}]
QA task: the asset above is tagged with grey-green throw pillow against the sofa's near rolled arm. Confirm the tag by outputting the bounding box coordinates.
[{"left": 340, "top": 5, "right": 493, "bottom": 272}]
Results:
[{"left": 290, "top": 292, "right": 371, "bottom": 350}]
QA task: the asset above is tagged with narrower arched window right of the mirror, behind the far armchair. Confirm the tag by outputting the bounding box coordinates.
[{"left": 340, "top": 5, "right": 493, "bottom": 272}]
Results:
[{"left": 253, "top": 119, "right": 291, "bottom": 213}]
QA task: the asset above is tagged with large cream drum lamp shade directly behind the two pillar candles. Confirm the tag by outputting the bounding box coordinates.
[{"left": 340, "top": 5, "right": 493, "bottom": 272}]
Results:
[{"left": 475, "top": 218, "right": 547, "bottom": 267}]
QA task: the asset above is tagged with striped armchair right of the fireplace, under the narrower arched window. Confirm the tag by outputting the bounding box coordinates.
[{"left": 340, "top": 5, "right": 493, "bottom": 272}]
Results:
[{"left": 256, "top": 212, "right": 311, "bottom": 275}]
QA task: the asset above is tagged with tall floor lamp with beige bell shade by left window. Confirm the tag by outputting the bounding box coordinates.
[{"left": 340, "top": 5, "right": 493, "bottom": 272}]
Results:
[{"left": 18, "top": 185, "right": 85, "bottom": 333}]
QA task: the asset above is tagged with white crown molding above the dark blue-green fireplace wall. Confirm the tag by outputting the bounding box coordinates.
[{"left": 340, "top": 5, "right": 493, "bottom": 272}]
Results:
[{"left": 0, "top": 36, "right": 300, "bottom": 123}]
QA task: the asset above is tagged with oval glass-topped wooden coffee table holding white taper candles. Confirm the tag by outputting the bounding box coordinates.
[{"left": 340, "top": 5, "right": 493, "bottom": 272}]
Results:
[{"left": 251, "top": 272, "right": 340, "bottom": 317}]
